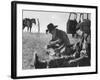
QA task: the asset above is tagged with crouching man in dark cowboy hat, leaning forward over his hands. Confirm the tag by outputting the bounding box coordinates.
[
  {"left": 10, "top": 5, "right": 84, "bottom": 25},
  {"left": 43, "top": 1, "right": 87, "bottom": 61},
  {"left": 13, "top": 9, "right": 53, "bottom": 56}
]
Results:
[{"left": 46, "top": 23, "right": 71, "bottom": 55}]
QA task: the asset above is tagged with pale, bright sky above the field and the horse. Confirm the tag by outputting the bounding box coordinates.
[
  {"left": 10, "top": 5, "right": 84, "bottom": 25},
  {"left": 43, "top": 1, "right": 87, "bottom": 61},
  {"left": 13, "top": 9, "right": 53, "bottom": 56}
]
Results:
[{"left": 23, "top": 10, "right": 90, "bottom": 33}]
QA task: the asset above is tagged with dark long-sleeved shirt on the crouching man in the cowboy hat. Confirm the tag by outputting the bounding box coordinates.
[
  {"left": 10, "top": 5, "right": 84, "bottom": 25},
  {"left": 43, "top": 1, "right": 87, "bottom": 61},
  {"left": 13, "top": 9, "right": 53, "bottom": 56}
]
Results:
[{"left": 51, "top": 29, "right": 70, "bottom": 55}]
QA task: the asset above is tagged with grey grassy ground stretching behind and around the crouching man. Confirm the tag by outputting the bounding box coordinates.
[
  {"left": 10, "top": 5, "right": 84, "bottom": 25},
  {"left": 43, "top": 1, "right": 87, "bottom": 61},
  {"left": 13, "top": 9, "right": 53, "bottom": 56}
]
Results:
[{"left": 22, "top": 32, "right": 76, "bottom": 69}]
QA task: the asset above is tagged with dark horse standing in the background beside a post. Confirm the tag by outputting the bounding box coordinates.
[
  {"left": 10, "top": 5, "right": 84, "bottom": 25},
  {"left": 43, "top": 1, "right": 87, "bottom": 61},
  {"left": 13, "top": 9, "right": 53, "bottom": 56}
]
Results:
[{"left": 23, "top": 18, "right": 36, "bottom": 32}]
